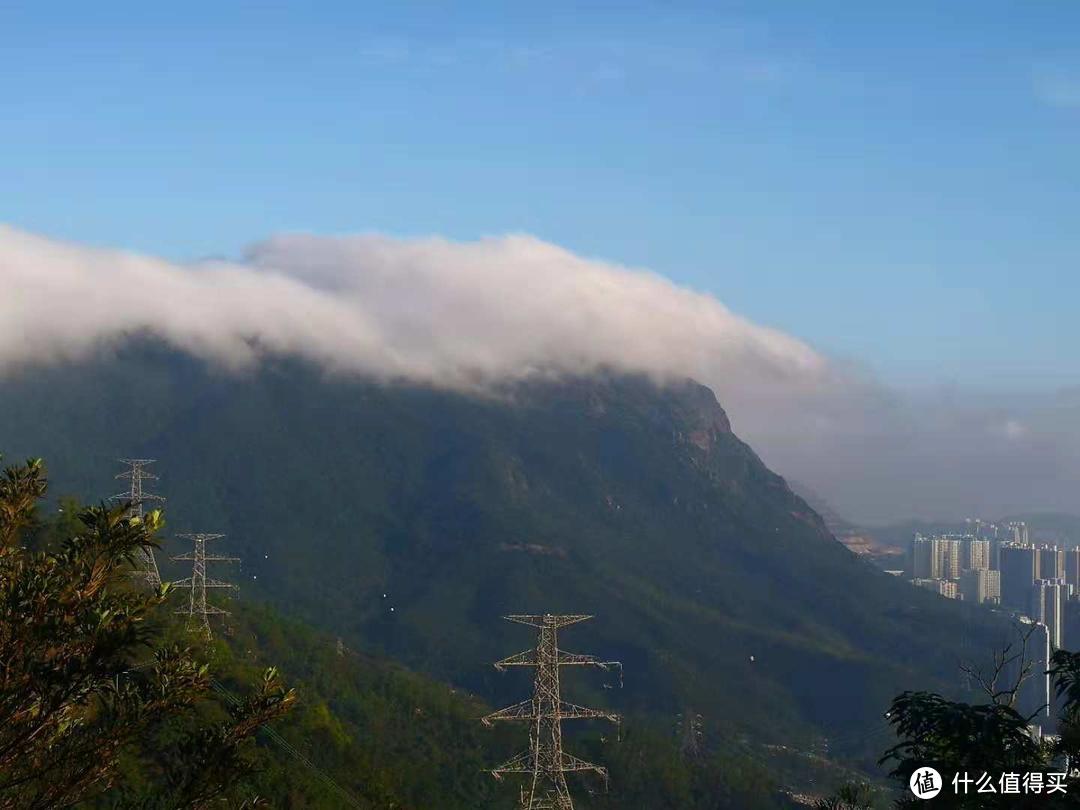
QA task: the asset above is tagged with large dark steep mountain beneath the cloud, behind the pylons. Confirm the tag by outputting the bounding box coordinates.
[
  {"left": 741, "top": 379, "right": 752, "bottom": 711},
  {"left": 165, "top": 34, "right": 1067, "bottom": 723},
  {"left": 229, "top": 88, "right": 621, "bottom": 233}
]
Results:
[{"left": 0, "top": 343, "right": 1010, "bottom": 768}]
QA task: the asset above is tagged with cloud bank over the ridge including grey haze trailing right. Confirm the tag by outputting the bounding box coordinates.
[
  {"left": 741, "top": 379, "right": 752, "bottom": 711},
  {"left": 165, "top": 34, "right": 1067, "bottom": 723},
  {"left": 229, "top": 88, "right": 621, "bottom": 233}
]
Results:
[{"left": 0, "top": 227, "right": 1080, "bottom": 518}]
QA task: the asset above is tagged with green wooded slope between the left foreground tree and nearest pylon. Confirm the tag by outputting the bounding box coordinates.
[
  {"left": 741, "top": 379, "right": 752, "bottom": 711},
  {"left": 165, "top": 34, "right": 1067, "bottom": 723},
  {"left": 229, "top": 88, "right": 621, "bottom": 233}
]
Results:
[{"left": 199, "top": 604, "right": 518, "bottom": 810}]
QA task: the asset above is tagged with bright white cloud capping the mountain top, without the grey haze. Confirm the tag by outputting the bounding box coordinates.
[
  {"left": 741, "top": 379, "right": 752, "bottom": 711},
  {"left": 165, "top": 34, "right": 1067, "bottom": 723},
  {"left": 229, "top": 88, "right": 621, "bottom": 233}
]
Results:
[{"left": 0, "top": 228, "right": 827, "bottom": 388}]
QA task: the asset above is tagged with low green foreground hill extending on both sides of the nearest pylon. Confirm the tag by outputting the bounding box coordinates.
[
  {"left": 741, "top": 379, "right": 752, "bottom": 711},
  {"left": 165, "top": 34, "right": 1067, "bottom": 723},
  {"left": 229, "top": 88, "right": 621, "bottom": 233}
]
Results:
[{"left": 143, "top": 605, "right": 791, "bottom": 810}]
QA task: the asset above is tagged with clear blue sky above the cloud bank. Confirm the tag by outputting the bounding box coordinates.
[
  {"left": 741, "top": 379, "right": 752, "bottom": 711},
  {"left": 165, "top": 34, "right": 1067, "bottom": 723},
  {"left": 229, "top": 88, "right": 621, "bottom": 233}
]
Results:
[{"left": 0, "top": 0, "right": 1080, "bottom": 390}]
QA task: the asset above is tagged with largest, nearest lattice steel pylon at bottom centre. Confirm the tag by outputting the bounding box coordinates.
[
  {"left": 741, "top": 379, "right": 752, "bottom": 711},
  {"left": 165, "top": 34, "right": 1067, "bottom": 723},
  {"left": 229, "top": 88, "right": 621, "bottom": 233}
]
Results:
[{"left": 483, "top": 613, "right": 622, "bottom": 810}]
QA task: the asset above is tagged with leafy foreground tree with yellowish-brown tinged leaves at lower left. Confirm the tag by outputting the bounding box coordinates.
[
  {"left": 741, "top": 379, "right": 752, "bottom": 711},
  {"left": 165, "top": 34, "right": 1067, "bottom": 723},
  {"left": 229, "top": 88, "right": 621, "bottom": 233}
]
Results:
[{"left": 0, "top": 459, "right": 296, "bottom": 810}]
